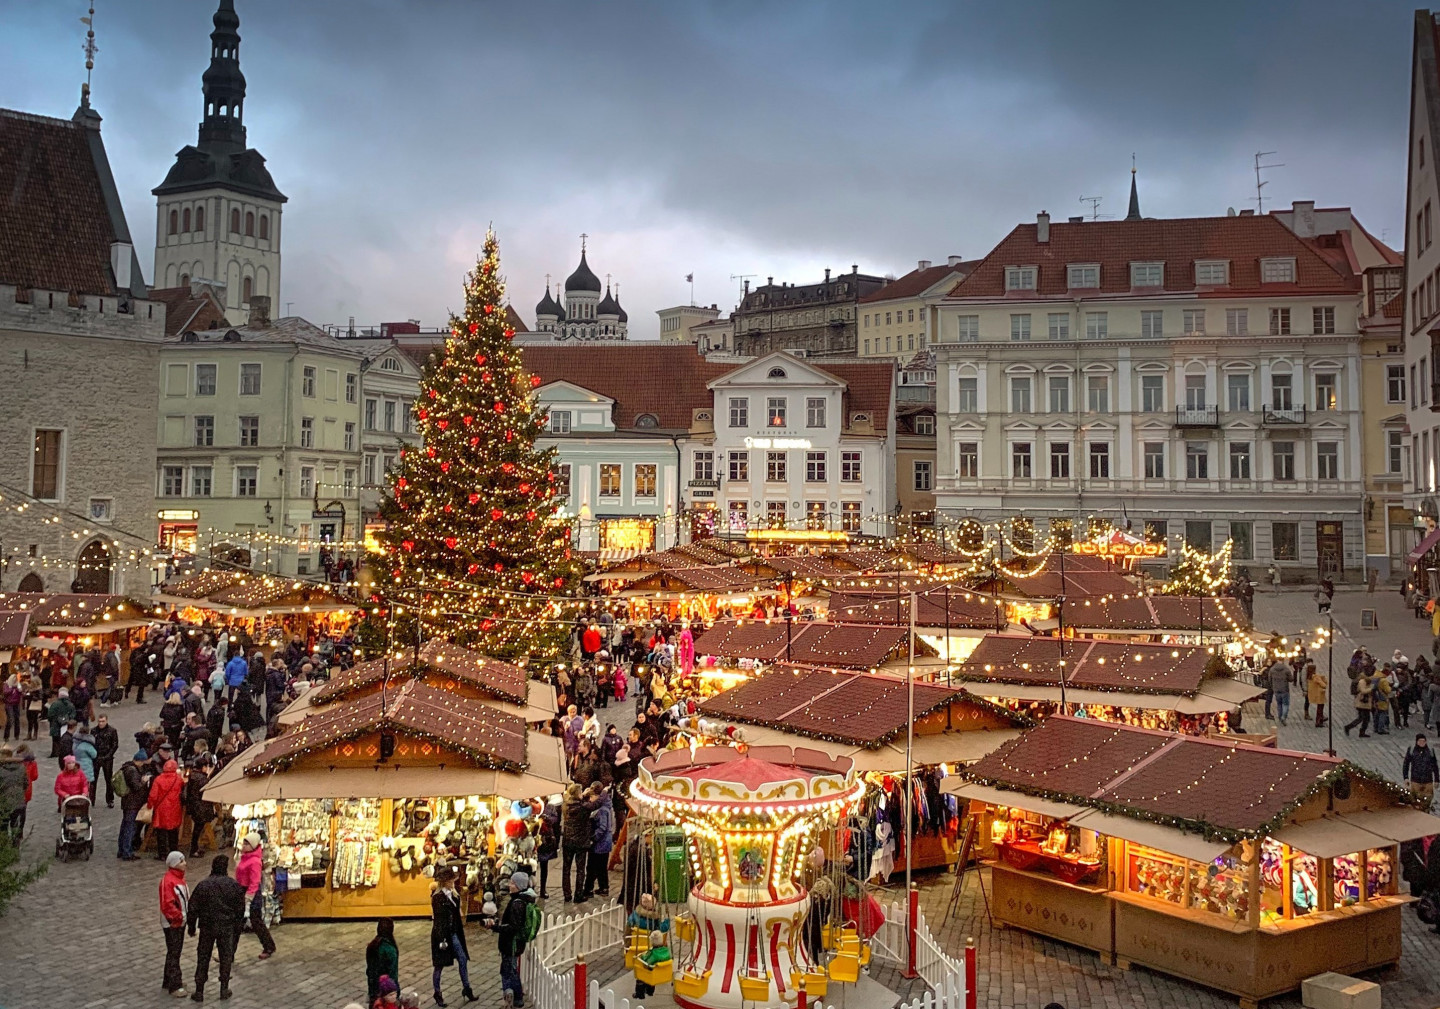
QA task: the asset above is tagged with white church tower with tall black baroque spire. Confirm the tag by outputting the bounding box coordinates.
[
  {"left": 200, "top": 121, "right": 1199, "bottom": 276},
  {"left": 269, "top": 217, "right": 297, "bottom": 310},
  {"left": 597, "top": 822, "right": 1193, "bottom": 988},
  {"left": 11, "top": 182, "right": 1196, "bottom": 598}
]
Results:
[{"left": 151, "top": 0, "right": 287, "bottom": 325}]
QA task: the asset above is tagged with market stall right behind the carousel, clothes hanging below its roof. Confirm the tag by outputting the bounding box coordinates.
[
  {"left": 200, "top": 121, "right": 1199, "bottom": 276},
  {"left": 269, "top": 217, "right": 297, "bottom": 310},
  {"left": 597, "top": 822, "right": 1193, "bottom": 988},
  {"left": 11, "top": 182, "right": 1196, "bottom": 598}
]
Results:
[{"left": 693, "top": 665, "right": 1034, "bottom": 872}]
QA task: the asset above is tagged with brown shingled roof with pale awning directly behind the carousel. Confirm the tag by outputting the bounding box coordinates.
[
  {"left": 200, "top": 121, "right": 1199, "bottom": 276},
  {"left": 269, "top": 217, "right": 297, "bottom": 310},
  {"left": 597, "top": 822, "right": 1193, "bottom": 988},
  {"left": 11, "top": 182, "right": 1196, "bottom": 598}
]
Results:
[{"left": 700, "top": 664, "right": 1032, "bottom": 770}]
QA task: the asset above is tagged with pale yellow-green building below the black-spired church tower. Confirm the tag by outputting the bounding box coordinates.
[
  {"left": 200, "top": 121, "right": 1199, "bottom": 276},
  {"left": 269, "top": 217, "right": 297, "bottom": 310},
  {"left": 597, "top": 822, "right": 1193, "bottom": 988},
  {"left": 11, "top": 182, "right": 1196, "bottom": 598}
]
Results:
[{"left": 156, "top": 303, "right": 363, "bottom": 574}]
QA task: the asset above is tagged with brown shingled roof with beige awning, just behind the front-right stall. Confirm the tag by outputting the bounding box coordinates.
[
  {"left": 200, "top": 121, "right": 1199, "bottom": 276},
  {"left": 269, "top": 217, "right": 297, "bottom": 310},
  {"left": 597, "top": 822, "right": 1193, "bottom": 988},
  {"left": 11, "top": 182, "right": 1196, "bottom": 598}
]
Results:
[{"left": 953, "top": 635, "right": 1264, "bottom": 714}]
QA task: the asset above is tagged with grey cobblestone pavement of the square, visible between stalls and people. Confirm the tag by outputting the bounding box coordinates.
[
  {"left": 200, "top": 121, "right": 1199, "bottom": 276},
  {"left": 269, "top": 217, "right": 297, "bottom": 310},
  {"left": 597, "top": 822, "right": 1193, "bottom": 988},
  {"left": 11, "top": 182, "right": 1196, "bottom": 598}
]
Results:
[{"left": 0, "top": 590, "right": 1440, "bottom": 1009}]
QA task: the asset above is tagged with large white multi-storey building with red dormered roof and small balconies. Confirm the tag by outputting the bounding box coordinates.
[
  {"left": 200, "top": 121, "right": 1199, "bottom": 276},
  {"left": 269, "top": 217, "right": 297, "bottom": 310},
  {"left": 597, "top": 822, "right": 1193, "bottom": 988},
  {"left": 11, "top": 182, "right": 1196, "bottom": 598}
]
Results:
[{"left": 930, "top": 207, "right": 1365, "bottom": 579}]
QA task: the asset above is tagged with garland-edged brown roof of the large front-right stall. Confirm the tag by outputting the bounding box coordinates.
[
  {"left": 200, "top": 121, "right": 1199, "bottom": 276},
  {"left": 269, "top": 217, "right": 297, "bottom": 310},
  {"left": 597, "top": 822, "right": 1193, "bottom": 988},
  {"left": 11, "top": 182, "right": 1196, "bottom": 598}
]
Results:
[{"left": 945, "top": 715, "right": 1440, "bottom": 858}]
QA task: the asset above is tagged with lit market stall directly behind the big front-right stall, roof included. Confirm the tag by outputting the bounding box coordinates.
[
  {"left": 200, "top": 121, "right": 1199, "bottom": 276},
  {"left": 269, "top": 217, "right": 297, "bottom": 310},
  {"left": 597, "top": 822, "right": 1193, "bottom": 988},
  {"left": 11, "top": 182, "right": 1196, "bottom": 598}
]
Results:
[{"left": 953, "top": 635, "right": 1264, "bottom": 736}]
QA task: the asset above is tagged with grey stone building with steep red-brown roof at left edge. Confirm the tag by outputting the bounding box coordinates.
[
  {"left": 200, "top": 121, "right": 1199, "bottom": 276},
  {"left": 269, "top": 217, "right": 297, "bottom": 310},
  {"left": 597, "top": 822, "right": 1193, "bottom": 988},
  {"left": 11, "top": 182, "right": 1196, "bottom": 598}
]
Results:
[{"left": 0, "top": 98, "right": 166, "bottom": 594}]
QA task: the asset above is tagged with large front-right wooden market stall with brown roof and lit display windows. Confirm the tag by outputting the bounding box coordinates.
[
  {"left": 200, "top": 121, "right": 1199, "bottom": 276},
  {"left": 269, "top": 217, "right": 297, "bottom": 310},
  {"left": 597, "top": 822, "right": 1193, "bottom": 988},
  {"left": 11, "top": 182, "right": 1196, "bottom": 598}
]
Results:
[{"left": 945, "top": 717, "right": 1440, "bottom": 1009}]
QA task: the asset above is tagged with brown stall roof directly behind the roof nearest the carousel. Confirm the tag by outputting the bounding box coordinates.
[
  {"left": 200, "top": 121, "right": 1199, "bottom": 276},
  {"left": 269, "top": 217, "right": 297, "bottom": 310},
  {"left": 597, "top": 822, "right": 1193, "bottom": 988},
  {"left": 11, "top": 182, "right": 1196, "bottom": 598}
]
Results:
[{"left": 696, "top": 619, "right": 935, "bottom": 669}]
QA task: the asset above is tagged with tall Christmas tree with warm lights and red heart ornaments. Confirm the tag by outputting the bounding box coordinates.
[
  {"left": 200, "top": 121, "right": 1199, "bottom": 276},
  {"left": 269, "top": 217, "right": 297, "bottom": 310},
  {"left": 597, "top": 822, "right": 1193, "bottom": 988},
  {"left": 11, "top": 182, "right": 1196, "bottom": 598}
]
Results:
[{"left": 382, "top": 232, "right": 575, "bottom": 658}]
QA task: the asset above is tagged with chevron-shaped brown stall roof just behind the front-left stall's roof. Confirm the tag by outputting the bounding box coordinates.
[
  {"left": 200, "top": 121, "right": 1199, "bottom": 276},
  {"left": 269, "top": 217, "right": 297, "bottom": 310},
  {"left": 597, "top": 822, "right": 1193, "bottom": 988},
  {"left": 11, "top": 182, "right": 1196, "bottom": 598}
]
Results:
[{"left": 279, "top": 638, "right": 556, "bottom": 727}]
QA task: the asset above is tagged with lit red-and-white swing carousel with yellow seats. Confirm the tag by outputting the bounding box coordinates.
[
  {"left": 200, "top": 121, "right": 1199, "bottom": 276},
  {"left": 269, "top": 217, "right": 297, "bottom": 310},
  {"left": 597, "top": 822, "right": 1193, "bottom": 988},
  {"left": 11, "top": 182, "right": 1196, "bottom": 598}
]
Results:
[{"left": 626, "top": 746, "right": 878, "bottom": 1009}]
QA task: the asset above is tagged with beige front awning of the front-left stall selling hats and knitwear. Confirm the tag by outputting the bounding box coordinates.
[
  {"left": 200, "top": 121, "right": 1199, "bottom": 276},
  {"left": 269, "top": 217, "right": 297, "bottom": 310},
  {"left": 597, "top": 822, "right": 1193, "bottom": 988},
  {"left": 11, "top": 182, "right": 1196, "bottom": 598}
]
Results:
[{"left": 204, "top": 731, "right": 569, "bottom": 805}]
